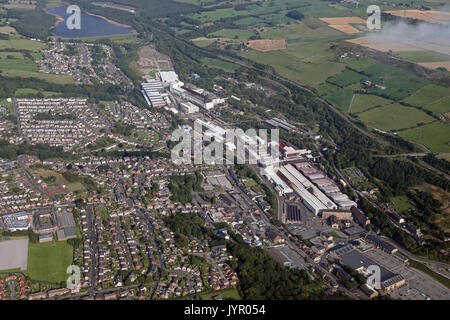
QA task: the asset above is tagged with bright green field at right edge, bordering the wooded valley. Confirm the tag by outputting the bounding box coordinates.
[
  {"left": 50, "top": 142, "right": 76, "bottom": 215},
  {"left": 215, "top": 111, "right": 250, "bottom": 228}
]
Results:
[{"left": 398, "top": 122, "right": 450, "bottom": 152}]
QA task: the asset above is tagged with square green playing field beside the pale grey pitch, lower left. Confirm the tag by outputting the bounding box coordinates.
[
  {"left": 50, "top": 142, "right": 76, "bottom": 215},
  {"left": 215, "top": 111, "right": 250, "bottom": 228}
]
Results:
[{"left": 26, "top": 241, "right": 73, "bottom": 282}]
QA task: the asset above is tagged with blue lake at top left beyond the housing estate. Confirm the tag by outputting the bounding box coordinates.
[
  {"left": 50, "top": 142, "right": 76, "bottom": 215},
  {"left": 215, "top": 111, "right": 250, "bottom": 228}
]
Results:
[{"left": 48, "top": 6, "right": 133, "bottom": 38}]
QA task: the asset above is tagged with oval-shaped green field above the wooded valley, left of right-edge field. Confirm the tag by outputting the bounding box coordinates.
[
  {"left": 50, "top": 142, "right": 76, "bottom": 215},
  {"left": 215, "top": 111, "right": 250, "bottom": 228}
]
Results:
[{"left": 358, "top": 104, "right": 434, "bottom": 131}]
